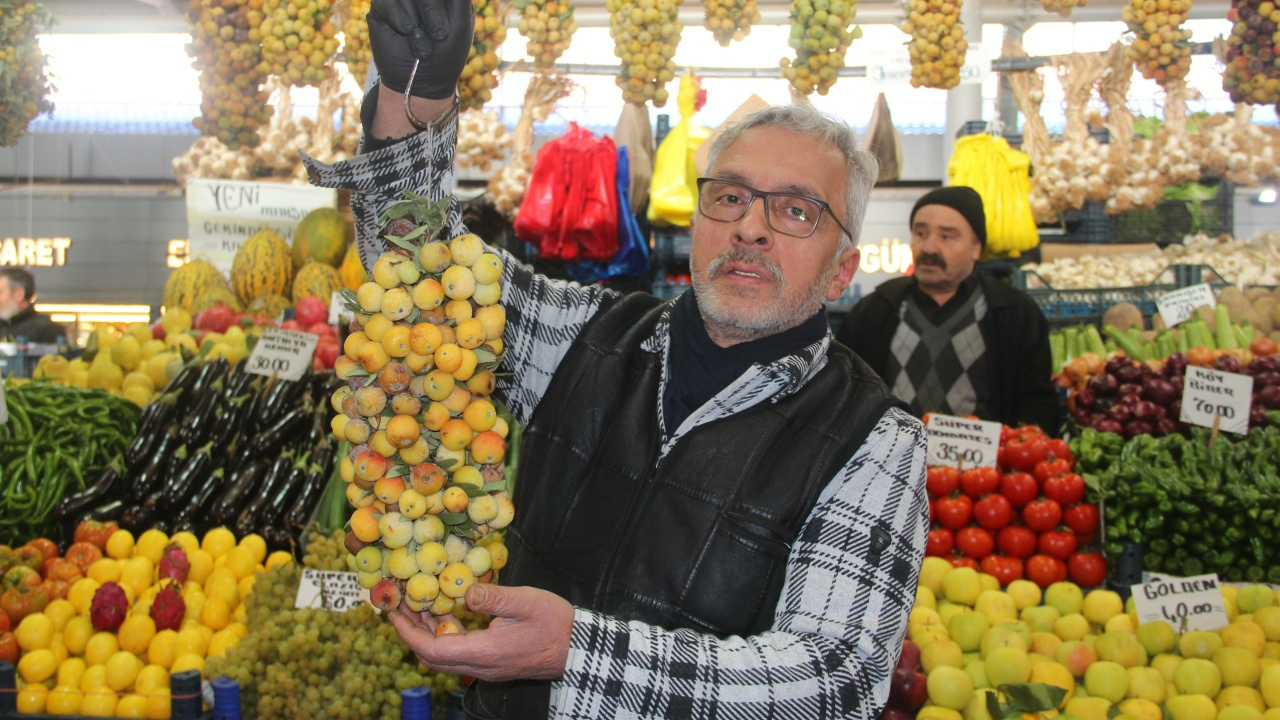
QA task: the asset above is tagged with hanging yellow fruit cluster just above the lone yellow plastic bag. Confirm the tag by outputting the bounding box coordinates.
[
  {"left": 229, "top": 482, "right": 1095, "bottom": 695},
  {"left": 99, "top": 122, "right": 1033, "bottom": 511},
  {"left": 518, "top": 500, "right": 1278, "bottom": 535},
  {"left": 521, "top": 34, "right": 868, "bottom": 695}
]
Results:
[{"left": 605, "top": 0, "right": 685, "bottom": 108}]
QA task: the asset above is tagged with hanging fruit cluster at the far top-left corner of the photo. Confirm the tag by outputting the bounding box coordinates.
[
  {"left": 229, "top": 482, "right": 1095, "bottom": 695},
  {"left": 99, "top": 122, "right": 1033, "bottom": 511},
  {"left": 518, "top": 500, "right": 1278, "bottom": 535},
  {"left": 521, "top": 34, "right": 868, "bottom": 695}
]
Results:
[{"left": 0, "top": 0, "right": 54, "bottom": 147}]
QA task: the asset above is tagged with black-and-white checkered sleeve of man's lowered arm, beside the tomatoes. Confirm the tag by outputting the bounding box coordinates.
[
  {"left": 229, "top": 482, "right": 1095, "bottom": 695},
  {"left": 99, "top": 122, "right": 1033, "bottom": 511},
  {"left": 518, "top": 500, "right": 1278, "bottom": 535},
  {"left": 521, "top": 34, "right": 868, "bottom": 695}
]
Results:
[{"left": 552, "top": 409, "right": 928, "bottom": 720}]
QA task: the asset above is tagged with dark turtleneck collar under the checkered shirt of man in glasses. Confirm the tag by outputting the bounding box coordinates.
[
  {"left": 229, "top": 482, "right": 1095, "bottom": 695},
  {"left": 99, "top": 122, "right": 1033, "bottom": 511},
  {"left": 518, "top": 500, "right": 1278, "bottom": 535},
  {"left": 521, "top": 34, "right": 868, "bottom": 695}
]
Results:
[{"left": 662, "top": 290, "right": 828, "bottom": 434}]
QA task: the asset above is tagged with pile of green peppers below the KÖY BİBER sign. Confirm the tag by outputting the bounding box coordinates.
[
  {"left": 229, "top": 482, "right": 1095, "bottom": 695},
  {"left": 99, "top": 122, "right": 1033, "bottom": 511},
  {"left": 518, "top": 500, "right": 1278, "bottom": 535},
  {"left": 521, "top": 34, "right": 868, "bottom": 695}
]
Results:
[{"left": 1071, "top": 420, "right": 1280, "bottom": 584}]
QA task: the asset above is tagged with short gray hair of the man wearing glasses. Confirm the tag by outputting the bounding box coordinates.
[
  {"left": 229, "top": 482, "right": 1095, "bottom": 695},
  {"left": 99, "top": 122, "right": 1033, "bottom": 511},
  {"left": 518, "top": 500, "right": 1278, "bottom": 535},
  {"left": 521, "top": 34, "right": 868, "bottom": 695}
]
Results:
[{"left": 707, "top": 102, "right": 879, "bottom": 250}]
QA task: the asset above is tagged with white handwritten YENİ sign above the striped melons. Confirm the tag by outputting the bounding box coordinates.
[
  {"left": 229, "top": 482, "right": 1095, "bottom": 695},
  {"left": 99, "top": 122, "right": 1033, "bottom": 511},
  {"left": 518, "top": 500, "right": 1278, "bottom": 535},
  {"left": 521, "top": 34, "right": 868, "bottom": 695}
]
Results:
[{"left": 187, "top": 179, "right": 338, "bottom": 273}]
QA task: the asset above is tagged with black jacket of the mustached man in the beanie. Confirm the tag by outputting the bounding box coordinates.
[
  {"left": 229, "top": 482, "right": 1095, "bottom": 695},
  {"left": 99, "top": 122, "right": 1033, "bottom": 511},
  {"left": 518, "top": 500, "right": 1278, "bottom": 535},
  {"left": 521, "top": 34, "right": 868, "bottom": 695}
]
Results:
[{"left": 836, "top": 275, "right": 1060, "bottom": 434}]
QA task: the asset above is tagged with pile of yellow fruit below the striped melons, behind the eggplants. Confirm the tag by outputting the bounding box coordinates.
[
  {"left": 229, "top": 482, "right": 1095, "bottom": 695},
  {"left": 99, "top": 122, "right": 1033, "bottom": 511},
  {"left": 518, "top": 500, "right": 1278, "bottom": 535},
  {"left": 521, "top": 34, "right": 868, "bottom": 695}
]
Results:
[{"left": 32, "top": 316, "right": 198, "bottom": 407}]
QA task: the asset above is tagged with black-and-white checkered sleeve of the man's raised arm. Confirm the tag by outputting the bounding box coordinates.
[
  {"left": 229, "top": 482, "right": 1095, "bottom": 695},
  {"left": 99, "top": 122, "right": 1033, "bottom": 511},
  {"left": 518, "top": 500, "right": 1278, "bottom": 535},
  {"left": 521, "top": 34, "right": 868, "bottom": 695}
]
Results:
[{"left": 302, "top": 100, "right": 614, "bottom": 424}]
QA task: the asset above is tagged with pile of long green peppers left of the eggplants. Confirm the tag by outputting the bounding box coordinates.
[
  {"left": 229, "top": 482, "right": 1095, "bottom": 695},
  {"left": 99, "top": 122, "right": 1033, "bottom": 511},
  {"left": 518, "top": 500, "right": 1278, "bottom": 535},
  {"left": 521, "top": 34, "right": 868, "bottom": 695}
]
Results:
[{"left": 0, "top": 380, "right": 138, "bottom": 544}]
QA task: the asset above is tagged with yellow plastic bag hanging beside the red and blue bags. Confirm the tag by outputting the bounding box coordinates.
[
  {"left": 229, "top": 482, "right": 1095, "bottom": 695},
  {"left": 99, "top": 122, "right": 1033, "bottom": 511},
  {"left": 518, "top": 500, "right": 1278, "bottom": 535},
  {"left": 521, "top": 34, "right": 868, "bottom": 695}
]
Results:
[{"left": 648, "top": 72, "right": 710, "bottom": 228}]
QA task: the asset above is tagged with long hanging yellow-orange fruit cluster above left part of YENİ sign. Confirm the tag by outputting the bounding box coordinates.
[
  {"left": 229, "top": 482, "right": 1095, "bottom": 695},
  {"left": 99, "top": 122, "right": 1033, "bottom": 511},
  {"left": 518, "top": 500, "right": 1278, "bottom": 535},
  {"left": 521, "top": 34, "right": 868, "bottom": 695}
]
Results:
[{"left": 187, "top": 0, "right": 273, "bottom": 150}]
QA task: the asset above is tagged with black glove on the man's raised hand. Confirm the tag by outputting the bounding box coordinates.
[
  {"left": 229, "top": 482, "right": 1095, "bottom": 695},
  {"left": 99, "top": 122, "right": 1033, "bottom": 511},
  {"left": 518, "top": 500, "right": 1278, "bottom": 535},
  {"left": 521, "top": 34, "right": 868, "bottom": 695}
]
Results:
[{"left": 369, "top": 0, "right": 475, "bottom": 100}]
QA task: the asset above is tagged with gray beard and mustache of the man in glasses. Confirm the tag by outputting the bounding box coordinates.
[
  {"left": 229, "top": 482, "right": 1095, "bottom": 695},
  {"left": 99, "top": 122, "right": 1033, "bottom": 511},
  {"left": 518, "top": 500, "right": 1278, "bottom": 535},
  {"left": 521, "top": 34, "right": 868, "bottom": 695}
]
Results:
[{"left": 692, "top": 247, "right": 840, "bottom": 341}]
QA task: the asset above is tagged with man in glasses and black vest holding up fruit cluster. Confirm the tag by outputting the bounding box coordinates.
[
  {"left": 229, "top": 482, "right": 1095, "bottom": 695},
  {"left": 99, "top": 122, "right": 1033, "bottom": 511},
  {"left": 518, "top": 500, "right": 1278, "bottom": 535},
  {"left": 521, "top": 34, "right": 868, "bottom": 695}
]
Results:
[{"left": 306, "top": 0, "right": 928, "bottom": 720}]
